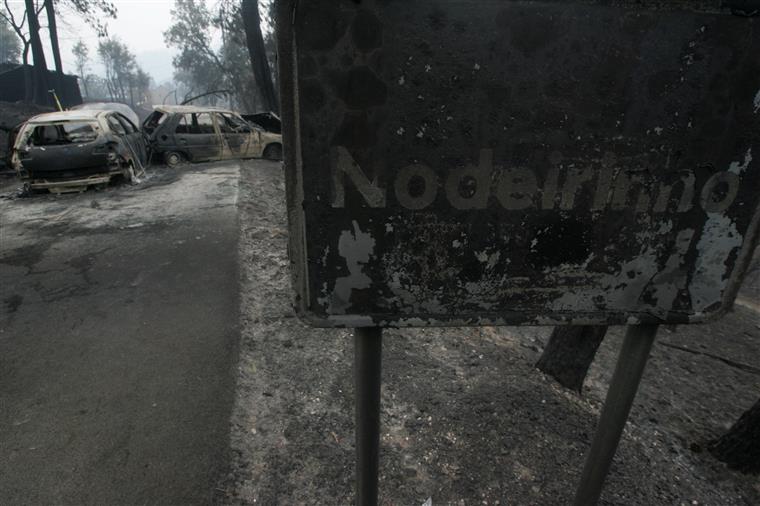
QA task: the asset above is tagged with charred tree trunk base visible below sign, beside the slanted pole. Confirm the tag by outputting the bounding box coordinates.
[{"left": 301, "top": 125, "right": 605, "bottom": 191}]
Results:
[{"left": 536, "top": 325, "right": 607, "bottom": 393}]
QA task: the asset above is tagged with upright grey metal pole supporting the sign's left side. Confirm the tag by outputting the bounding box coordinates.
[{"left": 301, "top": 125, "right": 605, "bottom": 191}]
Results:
[{"left": 354, "top": 327, "right": 383, "bottom": 506}]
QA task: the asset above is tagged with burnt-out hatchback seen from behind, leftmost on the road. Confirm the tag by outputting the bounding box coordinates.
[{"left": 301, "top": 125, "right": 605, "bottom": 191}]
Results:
[{"left": 11, "top": 110, "right": 148, "bottom": 190}]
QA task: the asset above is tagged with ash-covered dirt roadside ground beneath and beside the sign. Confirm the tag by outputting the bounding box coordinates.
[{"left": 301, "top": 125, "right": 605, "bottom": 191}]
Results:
[{"left": 220, "top": 162, "right": 760, "bottom": 505}]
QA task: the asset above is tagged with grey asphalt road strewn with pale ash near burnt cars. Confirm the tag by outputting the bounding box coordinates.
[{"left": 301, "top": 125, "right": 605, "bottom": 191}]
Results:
[{"left": 0, "top": 162, "right": 239, "bottom": 505}]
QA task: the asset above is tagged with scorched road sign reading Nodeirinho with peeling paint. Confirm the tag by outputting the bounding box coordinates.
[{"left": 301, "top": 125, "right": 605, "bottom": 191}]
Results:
[{"left": 278, "top": 0, "right": 760, "bottom": 327}]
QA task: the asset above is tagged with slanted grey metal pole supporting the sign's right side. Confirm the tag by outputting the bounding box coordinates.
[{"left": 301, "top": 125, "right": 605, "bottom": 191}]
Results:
[{"left": 573, "top": 325, "right": 657, "bottom": 506}]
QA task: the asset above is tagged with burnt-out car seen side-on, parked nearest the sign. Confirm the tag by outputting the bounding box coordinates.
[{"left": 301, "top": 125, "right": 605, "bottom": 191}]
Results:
[{"left": 142, "top": 105, "right": 282, "bottom": 166}]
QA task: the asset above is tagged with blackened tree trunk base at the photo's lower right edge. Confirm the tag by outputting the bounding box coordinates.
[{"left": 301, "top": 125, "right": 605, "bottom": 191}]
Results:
[{"left": 709, "top": 400, "right": 760, "bottom": 474}]
